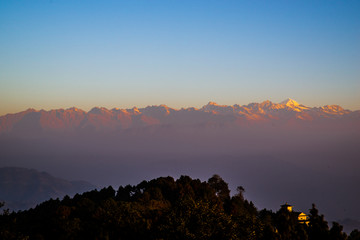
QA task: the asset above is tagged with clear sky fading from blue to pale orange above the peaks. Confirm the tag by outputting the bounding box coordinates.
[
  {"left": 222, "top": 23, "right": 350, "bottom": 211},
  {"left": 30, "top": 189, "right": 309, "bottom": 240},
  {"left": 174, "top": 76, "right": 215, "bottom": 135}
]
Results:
[{"left": 0, "top": 0, "right": 360, "bottom": 115}]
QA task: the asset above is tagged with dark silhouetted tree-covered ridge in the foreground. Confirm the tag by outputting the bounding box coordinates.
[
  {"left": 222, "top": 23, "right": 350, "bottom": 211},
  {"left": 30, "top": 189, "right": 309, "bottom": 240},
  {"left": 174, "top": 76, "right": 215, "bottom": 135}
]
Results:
[{"left": 0, "top": 175, "right": 360, "bottom": 240}]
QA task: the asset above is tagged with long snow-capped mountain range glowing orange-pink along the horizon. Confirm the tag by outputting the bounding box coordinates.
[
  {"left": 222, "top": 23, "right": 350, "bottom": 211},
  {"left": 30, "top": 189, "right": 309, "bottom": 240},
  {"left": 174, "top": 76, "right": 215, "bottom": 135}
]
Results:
[{"left": 0, "top": 99, "right": 360, "bottom": 135}]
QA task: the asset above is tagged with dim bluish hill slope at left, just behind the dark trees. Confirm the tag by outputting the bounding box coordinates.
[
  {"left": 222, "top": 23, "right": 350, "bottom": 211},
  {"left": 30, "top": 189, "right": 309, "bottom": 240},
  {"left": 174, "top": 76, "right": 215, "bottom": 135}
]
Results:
[{"left": 0, "top": 167, "right": 95, "bottom": 210}]
